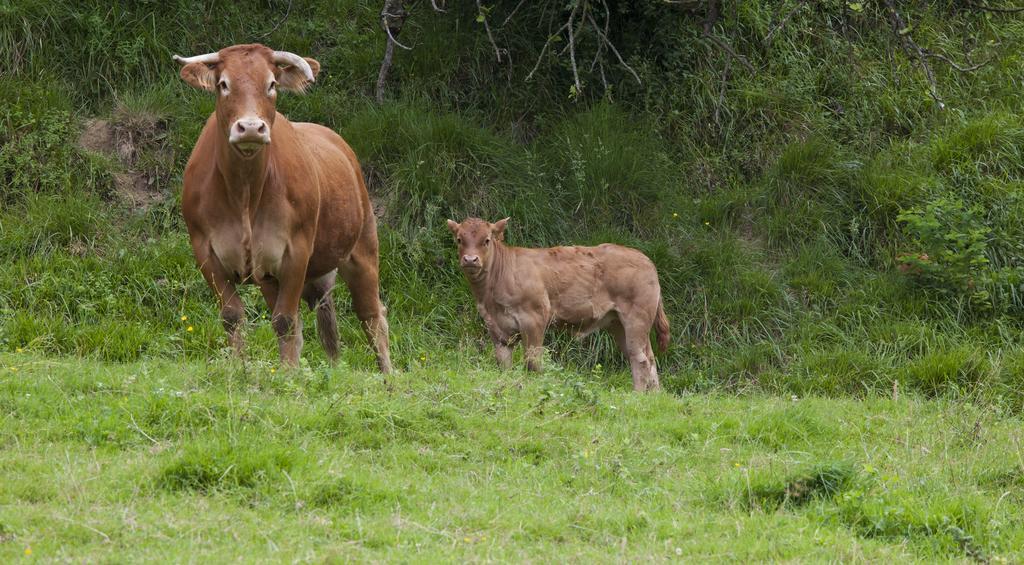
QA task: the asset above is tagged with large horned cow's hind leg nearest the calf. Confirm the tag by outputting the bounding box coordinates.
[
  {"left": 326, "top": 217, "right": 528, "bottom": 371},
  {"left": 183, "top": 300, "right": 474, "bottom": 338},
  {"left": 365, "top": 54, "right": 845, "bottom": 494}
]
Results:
[{"left": 338, "top": 235, "right": 391, "bottom": 375}]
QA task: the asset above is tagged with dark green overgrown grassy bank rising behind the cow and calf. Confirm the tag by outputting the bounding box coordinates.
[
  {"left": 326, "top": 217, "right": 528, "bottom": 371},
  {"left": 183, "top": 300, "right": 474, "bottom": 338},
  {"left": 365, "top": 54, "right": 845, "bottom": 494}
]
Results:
[{"left": 6, "top": 0, "right": 1024, "bottom": 406}]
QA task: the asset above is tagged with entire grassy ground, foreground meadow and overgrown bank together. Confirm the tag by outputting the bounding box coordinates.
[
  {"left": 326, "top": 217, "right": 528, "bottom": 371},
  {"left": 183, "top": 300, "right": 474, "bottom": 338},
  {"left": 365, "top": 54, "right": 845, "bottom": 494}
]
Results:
[{"left": 6, "top": 0, "right": 1024, "bottom": 562}]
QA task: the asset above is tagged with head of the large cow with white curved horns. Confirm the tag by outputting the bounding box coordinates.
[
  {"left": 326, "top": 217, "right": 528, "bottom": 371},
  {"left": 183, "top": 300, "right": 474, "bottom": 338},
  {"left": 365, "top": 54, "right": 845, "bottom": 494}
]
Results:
[{"left": 174, "top": 44, "right": 319, "bottom": 159}]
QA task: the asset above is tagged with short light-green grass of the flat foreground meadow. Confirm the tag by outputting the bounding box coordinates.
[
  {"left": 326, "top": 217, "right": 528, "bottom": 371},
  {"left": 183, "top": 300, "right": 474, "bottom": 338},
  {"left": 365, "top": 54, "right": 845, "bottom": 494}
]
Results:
[{"left": 0, "top": 352, "right": 1024, "bottom": 562}]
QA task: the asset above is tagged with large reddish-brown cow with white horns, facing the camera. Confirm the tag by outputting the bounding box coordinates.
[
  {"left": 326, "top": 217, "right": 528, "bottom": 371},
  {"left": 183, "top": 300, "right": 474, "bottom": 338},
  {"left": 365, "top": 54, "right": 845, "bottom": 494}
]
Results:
[{"left": 174, "top": 45, "right": 391, "bottom": 373}]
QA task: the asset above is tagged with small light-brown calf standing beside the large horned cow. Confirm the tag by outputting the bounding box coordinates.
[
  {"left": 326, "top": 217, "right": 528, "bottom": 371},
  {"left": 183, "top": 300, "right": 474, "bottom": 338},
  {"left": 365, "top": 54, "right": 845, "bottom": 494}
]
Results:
[{"left": 447, "top": 218, "right": 669, "bottom": 391}]
